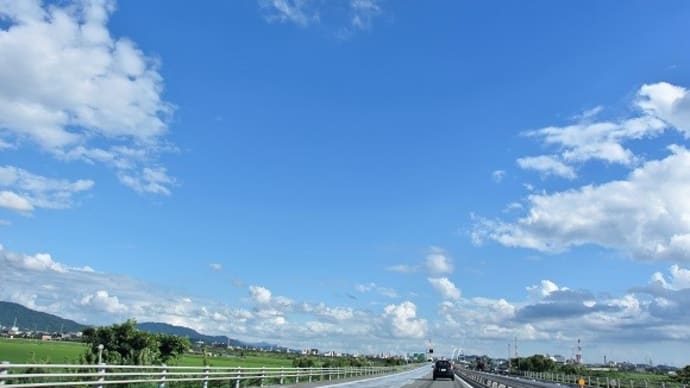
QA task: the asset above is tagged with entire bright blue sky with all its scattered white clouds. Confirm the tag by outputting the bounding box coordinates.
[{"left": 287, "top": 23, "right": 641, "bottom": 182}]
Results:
[{"left": 0, "top": 0, "right": 690, "bottom": 365}]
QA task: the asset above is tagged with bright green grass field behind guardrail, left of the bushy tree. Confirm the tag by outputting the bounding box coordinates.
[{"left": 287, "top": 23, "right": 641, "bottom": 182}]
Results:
[{"left": 0, "top": 338, "right": 86, "bottom": 364}]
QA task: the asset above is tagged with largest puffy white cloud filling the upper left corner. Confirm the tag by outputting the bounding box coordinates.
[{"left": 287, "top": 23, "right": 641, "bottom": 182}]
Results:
[{"left": 0, "top": 0, "right": 174, "bottom": 194}]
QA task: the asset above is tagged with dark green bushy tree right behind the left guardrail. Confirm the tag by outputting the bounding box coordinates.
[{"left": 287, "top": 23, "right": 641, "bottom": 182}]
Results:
[{"left": 82, "top": 319, "right": 190, "bottom": 365}]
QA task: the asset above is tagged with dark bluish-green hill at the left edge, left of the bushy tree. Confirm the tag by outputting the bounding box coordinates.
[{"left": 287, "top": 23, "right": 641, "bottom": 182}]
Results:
[{"left": 0, "top": 301, "right": 86, "bottom": 333}]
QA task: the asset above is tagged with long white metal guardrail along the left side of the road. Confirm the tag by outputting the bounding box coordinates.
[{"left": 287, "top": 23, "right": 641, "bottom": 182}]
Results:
[{"left": 0, "top": 362, "right": 408, "bottom": 388}]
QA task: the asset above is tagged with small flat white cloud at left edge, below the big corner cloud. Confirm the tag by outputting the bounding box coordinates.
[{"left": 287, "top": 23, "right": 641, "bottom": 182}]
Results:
[{"left": 0, "top": 166, "right": 94, "bottom": 212}]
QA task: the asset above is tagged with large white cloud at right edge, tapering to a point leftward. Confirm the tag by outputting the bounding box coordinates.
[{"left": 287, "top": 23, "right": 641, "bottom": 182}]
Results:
[{"left": 473, "top": 146, "right": 690, "bottom": 261}]
